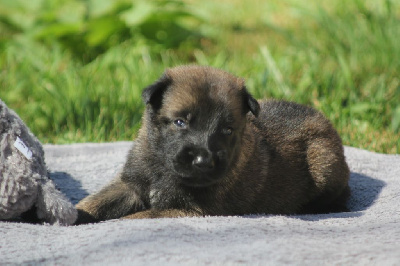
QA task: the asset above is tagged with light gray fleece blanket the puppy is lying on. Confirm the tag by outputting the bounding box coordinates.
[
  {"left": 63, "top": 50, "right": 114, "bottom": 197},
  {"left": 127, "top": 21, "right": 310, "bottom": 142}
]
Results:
[{"left": 0, "top": 142, "right": 400, "bottom": 265}]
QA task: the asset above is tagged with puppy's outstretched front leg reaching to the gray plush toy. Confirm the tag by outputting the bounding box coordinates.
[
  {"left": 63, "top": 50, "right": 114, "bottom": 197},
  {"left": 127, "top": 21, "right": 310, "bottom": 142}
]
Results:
[{"left": 75, "top": 177, "right": 145, "bottom": 224}]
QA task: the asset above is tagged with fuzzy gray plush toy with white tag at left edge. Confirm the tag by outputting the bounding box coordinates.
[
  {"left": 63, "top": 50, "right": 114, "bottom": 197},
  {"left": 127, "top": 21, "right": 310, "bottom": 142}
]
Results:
[{"left": 0, "top": 100, "right": 77, "bottom": 224}]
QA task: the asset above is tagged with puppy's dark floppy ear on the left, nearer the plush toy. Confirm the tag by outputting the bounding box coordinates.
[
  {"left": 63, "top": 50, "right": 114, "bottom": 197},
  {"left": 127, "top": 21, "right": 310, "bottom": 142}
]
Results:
[{"left": 142, "top": 74, "right": 172, "bottom": 110}]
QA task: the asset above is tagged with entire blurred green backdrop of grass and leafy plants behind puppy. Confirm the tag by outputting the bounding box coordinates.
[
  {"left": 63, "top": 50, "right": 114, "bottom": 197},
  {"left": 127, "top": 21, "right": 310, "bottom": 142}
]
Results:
[{"left": 0, "top": 0, "right": 400, "bottom": 153}]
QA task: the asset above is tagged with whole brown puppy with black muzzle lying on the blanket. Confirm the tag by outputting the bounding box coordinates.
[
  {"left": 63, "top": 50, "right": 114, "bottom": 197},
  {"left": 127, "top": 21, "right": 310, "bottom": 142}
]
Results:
[{"left": 77, "top": 66, "right": 349, "bottom": 223}]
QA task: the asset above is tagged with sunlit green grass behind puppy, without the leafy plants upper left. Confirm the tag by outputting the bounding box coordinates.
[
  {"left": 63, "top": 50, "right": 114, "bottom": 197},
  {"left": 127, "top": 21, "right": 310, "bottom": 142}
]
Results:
[{"left": 0, "top": 0, "right": 400, "bottom": 153}]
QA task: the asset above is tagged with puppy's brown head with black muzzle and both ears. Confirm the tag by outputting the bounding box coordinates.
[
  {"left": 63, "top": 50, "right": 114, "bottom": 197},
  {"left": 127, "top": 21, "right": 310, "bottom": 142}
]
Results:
[{"left": 142, "top": 66, "right": 260, "bottom": 187}]
